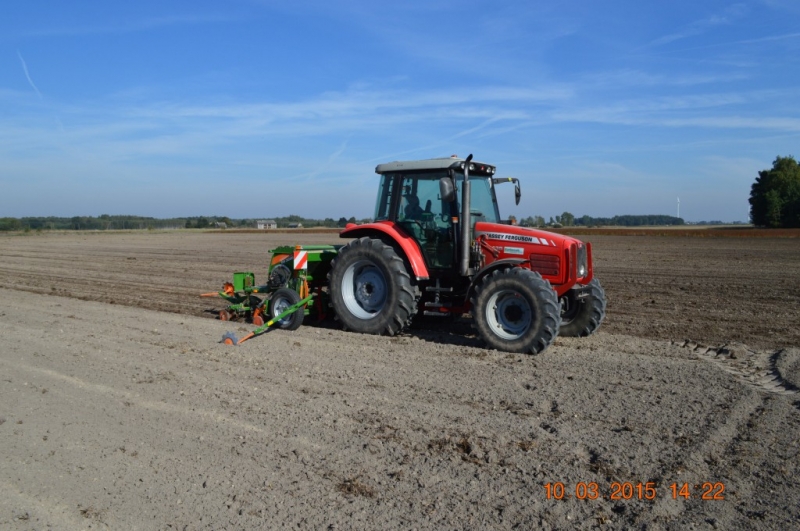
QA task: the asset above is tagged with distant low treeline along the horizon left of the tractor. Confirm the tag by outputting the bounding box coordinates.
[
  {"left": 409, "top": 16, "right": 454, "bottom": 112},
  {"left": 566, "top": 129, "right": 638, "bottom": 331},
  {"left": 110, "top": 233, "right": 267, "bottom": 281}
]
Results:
[{"left": 0, "top": 214, "right": 372, "bottom": 231}]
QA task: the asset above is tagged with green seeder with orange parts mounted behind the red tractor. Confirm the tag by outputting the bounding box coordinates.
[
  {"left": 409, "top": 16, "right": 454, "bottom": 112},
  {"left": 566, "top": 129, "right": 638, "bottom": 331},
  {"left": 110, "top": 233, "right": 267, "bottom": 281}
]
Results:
[{"left": 200, "top": 245, "right": 341, "bottom": 345}]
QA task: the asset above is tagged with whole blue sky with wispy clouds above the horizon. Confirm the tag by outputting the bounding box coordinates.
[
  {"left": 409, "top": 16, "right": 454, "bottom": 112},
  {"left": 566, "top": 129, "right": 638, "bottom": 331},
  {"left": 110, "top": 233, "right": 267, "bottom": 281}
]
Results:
[{"left": 0, "top": 0, "right": 800, "bottom": 221}]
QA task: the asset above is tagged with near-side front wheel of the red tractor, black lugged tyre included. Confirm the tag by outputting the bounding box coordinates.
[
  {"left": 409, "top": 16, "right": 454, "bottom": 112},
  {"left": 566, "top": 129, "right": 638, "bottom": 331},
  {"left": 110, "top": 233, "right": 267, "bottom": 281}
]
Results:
[{"left": 472, "top": 267, "right": 561, "bottom": 354}]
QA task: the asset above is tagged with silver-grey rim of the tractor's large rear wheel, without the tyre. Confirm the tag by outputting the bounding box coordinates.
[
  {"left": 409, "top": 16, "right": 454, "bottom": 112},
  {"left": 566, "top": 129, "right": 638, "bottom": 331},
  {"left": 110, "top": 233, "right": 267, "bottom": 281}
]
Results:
[{"left": 342, "top": 260, "right": 388, "bottom": 319}]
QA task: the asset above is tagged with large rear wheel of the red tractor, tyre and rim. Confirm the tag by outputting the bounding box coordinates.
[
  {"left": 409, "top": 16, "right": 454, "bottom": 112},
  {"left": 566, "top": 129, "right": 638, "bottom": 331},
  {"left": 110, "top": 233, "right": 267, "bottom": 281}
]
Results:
[{"left": 328, "top": 237, "right": 417, "bottom": 336}]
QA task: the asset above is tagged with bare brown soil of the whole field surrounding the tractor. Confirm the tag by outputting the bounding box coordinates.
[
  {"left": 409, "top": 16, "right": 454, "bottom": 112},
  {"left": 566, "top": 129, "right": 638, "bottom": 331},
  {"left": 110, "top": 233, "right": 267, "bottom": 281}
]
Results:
[{"left": 0, "top": 231, "right": 800, "bottom": 530}]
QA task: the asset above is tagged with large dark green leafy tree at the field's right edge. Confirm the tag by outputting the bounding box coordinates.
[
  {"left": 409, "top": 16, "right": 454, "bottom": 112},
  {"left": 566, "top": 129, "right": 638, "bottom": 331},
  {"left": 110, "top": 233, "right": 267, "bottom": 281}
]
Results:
[{"left": 750, "top": 156, "right": 800, "bottom": 228}]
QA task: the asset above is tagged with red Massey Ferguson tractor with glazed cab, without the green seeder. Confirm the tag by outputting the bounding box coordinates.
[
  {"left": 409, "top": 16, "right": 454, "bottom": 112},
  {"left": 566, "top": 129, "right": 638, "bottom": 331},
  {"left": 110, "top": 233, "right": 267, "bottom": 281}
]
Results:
[{"left": 327, "top": 155, "right": 606, "bottom": 353}]
